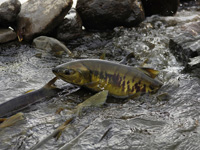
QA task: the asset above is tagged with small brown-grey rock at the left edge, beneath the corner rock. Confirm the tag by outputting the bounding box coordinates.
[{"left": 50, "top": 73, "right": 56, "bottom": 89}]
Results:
[{"left": 0, "top": 29, "right": 17, "bottom": 43}]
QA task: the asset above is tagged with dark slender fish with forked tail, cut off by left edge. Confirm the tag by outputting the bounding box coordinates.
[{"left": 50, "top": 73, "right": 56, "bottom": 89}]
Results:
[{"left": 0, "top": 77, "right": 63, "bottom": 117}]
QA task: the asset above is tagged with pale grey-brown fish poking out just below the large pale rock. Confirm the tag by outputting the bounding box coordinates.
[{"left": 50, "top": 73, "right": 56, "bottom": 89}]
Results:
[{"left": 32, "top": 36, "right": 72, "bottom": 56}]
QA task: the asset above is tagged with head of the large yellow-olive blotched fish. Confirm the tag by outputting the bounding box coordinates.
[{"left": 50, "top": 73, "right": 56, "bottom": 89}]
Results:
[{"left": 52, "top": 61, "right": 91, "bottom": 86}]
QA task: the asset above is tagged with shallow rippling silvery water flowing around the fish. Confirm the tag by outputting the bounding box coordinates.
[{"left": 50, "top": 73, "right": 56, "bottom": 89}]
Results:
[{"left": 0, "top": 4, "right": 200, "bottom": 150}]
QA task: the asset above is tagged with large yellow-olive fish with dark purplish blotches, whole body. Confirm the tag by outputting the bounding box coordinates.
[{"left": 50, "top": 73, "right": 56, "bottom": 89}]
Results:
[{"left": 52, "top": 59, "right": 163, "bottom": 98}]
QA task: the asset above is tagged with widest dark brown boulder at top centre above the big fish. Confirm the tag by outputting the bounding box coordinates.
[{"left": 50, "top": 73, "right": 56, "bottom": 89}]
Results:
[{"left": 76, "top": 0, "right": 145, "bottom": 29}]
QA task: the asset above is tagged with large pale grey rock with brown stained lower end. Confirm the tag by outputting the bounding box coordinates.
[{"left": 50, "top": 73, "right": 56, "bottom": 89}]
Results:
[{"left": 17, "top": 0, "right": 73, "bottom": 41}]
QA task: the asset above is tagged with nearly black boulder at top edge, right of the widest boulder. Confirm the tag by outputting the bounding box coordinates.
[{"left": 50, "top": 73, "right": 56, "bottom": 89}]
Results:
[{"left": 142, "top": 0, "right": 179, "bottom": 16}]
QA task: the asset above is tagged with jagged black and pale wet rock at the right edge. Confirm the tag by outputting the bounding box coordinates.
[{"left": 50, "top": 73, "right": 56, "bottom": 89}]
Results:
[{"left": 169, "top": 22, "right": 200, "bottom": 72}]
